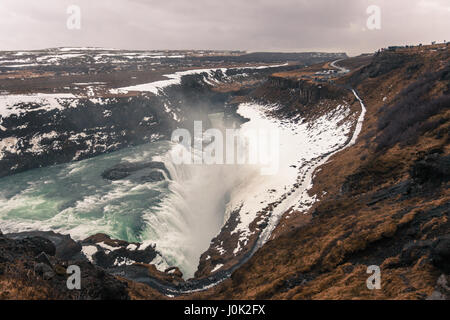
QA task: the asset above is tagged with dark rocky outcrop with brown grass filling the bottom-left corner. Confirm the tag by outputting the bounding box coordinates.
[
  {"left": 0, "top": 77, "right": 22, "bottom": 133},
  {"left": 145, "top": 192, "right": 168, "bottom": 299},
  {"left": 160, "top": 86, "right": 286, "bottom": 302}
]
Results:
[{"left": 0, "top": 233, "right": 129, "bottom": 300}]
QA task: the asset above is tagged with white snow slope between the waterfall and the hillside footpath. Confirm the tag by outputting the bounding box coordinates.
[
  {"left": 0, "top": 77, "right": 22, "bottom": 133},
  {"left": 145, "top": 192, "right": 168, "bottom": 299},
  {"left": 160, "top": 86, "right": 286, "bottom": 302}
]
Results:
[{"left": 220, "top": 91, "right": 366, "bottom": 255}]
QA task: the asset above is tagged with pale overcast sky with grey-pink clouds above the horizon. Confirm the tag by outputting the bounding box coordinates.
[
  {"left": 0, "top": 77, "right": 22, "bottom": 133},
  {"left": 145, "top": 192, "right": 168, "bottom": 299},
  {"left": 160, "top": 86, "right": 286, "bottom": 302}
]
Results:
[{"left": 0, "top": 0, "right": 450, "bottom": 55}]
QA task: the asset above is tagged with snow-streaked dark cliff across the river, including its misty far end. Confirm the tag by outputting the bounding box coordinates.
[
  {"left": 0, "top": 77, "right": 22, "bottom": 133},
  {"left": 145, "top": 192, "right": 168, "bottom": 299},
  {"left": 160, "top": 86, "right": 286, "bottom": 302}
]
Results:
[{"left": 0, "top": 69, "right": 268, "bottom": 177}]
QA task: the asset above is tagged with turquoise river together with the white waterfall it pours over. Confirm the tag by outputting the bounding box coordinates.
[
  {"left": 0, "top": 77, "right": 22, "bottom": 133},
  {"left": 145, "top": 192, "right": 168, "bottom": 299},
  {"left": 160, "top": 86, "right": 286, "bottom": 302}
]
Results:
[{"left": 0, "top": 136, "right": 248, "bottom": 278}]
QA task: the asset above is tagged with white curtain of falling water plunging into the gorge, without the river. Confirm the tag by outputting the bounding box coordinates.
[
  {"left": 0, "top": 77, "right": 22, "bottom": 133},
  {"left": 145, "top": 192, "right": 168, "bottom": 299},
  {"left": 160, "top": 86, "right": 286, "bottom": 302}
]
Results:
[{"left": 142, "top": 157, "right": 246, "bottom": 278}]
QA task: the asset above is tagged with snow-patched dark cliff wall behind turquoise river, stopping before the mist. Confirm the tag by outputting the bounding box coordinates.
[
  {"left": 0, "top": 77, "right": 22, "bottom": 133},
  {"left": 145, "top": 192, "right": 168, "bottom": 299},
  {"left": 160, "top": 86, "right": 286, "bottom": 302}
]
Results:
[{"left": 0, "top": 96, "right": 175, "bottom": 176}]
